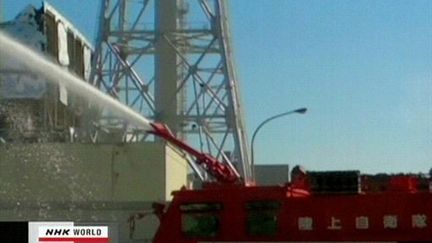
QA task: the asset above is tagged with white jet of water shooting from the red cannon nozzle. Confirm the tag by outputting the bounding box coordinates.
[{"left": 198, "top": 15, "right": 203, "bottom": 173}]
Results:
[{"left": 0, "top": 32, "right": 153, "bottom": 131}]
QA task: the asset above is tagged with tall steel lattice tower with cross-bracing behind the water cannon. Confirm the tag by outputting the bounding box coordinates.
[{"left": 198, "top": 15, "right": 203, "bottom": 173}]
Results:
[{"left": 92, "top": 0, "right": 250, "bottom": 180}]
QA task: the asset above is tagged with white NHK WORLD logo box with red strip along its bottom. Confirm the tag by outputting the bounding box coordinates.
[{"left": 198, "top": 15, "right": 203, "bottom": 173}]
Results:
[{"left": 38, "top": 226, "right": 109, "bottom": 243}]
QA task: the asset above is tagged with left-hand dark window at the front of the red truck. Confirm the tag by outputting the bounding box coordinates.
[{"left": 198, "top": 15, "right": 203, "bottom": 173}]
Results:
[{"left": 180, "top": 203, "right": 222, "bottom": 237}]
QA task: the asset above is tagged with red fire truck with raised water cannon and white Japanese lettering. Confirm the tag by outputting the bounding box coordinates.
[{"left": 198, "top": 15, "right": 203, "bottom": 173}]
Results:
[{"left": 139, "top": 124, "right": 432, "bottom": 243}]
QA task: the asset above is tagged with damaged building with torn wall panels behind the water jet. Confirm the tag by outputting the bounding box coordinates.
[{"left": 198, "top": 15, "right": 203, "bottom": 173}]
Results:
[{"left": 0, "top": 2, "right": 92, "bottom": 143}]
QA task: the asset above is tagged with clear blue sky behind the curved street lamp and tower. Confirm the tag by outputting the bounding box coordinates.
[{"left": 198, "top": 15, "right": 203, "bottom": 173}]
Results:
[{"left": 3, "top": 0, "right": 432, "bottom": 173}]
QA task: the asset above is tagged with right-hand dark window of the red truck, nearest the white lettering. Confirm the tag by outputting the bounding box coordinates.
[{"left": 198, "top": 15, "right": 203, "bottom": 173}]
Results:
[{"left": 246, "top": 201, "right": 281, "bottom": 236}]
